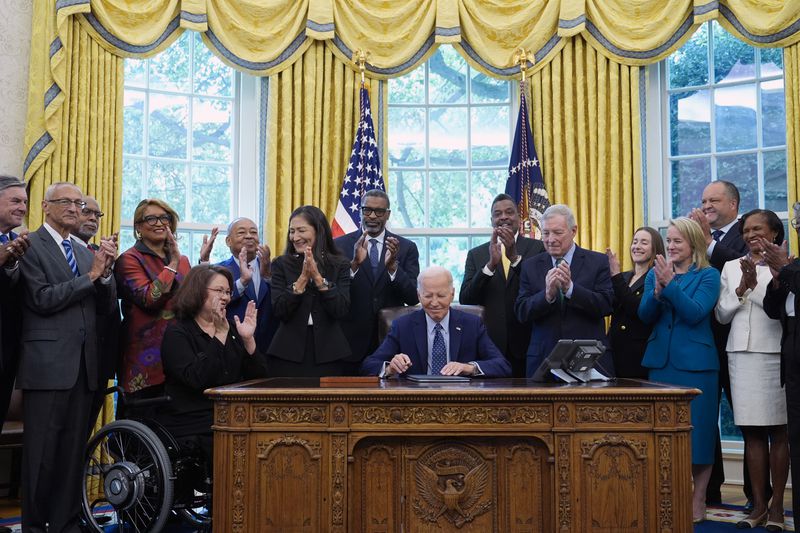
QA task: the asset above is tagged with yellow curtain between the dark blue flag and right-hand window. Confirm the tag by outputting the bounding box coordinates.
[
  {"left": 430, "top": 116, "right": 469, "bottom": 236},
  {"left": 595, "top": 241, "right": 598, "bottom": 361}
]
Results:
[{"left": 530, "top": 36, "right": 643, "bottom": 266}]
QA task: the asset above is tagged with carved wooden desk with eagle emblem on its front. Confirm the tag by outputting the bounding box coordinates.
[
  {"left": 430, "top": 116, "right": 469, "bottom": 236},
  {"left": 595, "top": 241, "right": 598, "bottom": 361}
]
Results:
[{"left": 208, "top": 379, "right": 698, "bottom": 533}]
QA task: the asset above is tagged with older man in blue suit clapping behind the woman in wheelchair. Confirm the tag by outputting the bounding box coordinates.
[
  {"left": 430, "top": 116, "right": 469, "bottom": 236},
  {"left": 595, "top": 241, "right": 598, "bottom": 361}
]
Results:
[{"left": 212, "top": 217, "right": 278, "bottom": 353}]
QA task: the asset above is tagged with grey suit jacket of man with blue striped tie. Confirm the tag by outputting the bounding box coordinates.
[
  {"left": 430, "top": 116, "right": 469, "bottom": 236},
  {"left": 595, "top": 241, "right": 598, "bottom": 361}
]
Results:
[{"left": 17, "top": 226, "right": 117, "bottom": 390}]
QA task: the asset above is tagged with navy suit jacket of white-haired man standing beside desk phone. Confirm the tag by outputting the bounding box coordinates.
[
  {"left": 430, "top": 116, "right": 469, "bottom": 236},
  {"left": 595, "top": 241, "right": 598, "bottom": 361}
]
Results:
[{"left": 514, "top": 246, "right": 614, "bottom": 377}]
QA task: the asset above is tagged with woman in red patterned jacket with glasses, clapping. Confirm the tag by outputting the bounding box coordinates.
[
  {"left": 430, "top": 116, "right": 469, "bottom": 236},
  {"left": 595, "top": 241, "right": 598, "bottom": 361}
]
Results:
[{"left": 114, "top": 199, "right": 191, "bottom": 417}]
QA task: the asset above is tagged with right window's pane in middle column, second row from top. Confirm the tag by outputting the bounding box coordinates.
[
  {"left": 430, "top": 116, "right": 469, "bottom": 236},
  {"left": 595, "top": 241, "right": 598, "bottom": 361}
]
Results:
[{"left": 714, "top": 85, "right": 757, "bottom": 151}]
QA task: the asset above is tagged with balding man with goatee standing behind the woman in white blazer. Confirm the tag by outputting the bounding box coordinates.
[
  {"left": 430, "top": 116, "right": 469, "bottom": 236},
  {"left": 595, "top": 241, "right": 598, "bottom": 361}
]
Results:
[{"left": 689, "top": 181, "right": 752, "bottom": 505}]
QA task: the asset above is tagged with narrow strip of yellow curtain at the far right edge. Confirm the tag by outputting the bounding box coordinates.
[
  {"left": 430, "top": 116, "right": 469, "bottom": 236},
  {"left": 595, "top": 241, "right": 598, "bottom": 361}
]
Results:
[{"left": 783, "top": 44, "right": 800, "bottom": 255}]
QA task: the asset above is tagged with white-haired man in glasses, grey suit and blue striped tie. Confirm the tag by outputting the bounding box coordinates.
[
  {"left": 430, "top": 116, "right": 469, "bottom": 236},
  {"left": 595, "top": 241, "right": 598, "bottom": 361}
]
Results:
[{"left": 17, "top": 183, "right": 117, "bottom": 532}]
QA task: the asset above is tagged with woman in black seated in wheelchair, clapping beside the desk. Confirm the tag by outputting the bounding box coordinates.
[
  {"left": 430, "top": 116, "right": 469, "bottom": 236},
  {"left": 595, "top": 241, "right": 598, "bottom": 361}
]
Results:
[{"left": 82, "top": 265, "right": 267, "bottom": 532}]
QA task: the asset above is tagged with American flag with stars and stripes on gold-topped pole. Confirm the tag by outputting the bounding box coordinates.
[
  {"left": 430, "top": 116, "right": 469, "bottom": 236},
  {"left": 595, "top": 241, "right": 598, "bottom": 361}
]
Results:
[{"left": 331, "top": 85, "right": 386, "bottom": 238}]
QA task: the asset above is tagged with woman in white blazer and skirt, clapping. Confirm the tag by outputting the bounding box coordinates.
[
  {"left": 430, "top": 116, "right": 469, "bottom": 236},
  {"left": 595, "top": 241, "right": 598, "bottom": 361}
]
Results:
[{"left": 714, "top": 209, "right": 789, "bottom": 531}]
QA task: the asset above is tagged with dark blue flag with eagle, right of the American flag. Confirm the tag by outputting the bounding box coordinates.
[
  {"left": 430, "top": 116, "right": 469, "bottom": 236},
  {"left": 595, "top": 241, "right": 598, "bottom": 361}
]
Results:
[{"left": 506, "top": 81, "right": 550, "bottom": 238}]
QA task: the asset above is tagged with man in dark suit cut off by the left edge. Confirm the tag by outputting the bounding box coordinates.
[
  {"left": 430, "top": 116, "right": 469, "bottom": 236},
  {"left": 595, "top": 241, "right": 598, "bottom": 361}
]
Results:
[{"left": 0, "top": 176, "right": 30, "bottom": 446}]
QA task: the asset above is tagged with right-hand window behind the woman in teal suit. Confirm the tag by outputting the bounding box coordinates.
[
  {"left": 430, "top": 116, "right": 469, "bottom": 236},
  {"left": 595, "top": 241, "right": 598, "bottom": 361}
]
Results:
[{"left": 656, "top": 22, "right": 787, "bottom": 224}]
